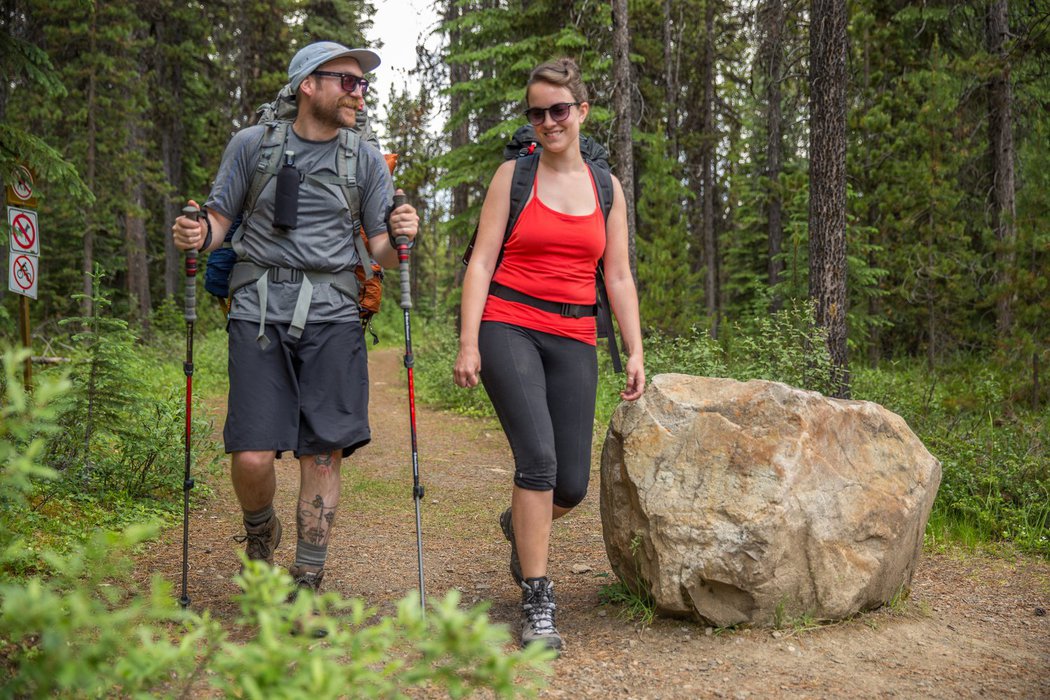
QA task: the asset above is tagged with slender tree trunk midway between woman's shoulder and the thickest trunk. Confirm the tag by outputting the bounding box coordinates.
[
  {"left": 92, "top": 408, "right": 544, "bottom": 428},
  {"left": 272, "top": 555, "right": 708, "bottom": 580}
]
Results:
[{"left": 700, "top": 0, "right": 720, "bottom": 338}]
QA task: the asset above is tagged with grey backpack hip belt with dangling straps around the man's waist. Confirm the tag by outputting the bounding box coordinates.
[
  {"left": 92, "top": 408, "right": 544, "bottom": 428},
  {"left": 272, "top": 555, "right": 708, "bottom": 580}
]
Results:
[{"left": 230, "top": 260, "right": 359, "bottom": 349}]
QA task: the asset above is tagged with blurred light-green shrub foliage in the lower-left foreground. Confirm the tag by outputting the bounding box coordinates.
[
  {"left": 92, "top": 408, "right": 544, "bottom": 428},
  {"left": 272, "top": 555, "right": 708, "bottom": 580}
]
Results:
[{"left": 0, "top": 351, "right": 553, "bottom": 698}]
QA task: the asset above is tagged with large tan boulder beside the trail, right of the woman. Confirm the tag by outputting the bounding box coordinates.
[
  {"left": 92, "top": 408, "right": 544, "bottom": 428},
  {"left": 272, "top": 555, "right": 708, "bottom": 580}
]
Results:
[{"left": 601, "top": 375, "right": 941, "bottom": 627}]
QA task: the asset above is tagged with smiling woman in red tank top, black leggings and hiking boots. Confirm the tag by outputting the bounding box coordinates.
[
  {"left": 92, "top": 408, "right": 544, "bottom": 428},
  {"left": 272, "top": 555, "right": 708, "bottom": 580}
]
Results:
[{"left": 454, "top": 59, "right": 646, "bottom": 650}]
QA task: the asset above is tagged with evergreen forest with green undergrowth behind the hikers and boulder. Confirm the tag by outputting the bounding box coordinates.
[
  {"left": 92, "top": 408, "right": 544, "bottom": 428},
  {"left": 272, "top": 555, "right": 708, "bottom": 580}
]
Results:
[{"left": 0, "top": 0, "right": 1050, "bottom": 690}]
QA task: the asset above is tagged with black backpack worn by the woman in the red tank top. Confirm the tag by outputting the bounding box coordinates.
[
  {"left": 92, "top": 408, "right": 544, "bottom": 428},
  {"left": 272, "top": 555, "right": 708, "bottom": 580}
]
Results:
[{"left": 463, "top": 124, "right": 624, "bottom": 372}]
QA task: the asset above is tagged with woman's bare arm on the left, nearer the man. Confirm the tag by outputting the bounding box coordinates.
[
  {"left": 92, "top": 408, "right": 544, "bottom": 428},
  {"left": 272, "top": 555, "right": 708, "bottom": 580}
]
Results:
[{"left": 453, "top": 161, "right": 515, "bottom": 387}]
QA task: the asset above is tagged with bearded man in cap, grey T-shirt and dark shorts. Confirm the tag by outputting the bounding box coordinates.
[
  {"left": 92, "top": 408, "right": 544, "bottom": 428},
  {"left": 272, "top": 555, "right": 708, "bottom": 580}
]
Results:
[{"left": 172, "top": 42, "right": 419, "bottom": 590}]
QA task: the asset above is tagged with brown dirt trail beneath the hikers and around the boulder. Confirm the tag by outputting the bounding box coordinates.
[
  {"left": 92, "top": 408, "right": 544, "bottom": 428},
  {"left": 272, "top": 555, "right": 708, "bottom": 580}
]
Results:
[{"left": 140, "top": 347, "right": 1050, "bottom": 700}]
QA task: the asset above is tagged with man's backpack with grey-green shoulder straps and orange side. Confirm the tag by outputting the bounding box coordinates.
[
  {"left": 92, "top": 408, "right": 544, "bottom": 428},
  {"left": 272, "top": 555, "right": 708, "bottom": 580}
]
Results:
[{"left": 204, "top": 85, "right": 397, "bottom": 342}]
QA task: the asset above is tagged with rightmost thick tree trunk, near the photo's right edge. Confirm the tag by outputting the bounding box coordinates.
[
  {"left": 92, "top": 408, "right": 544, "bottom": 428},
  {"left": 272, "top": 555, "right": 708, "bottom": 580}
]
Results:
[{"left": 985, "top": 0, "right": 1017, "bottom": 338}]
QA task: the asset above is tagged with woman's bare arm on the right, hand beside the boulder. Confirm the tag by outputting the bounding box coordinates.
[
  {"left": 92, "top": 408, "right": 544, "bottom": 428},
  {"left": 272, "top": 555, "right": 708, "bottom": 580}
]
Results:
[{"left": 605, "top": 176, "right": 646, "bottom": 401}]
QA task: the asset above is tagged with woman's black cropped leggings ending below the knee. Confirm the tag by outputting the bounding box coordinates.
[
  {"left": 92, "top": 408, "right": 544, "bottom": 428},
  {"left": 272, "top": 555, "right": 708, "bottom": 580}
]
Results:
[{"left": 478, "top": 321, "right": 597, "bottom": 508}]
